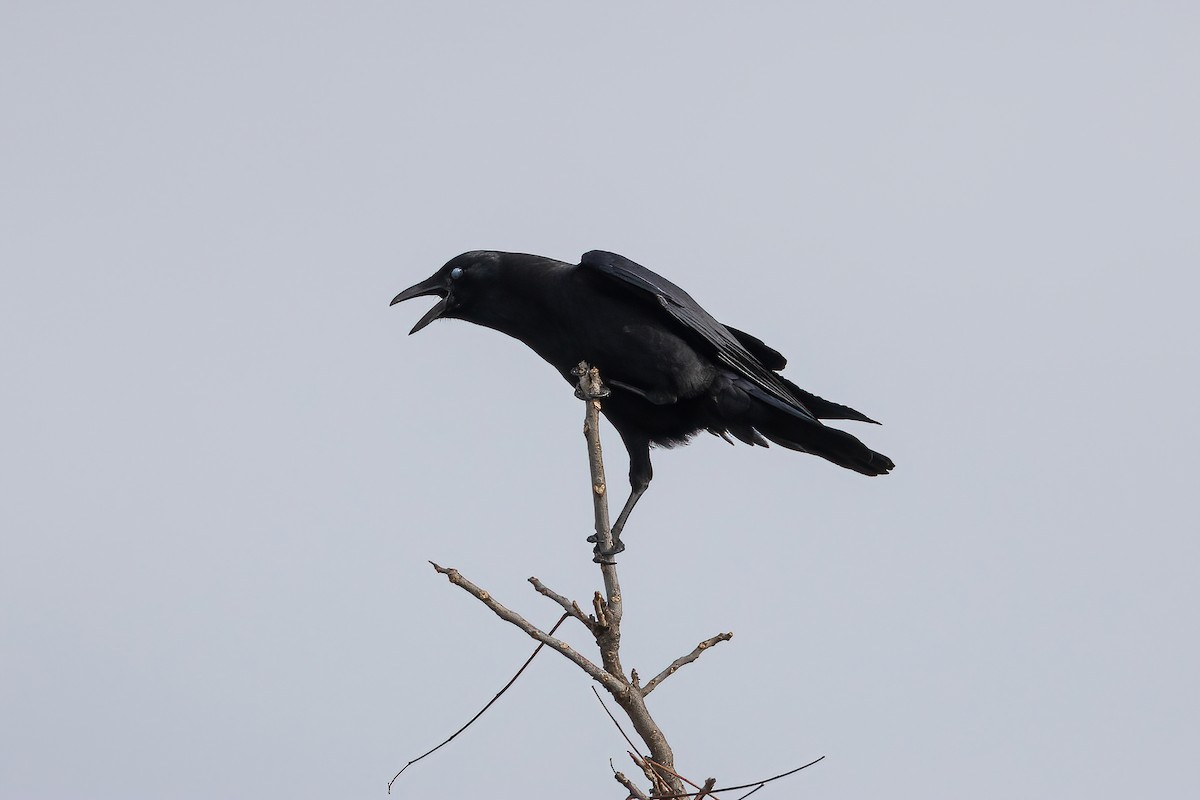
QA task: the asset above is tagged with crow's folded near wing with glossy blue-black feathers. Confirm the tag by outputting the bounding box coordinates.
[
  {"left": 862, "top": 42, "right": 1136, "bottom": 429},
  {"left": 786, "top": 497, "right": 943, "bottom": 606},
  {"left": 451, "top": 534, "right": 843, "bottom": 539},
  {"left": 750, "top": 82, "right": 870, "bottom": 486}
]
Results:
[{"left": 580, "top": 249, "right": 816, "bottom": 420}]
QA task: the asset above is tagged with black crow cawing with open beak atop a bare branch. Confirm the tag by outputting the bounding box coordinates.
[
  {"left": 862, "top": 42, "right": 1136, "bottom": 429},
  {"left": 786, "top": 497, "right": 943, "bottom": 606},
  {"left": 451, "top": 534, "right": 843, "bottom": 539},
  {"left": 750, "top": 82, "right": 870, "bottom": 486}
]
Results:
[{"left": 391, "top": 251, "right": 894, "bottom": 553}]
